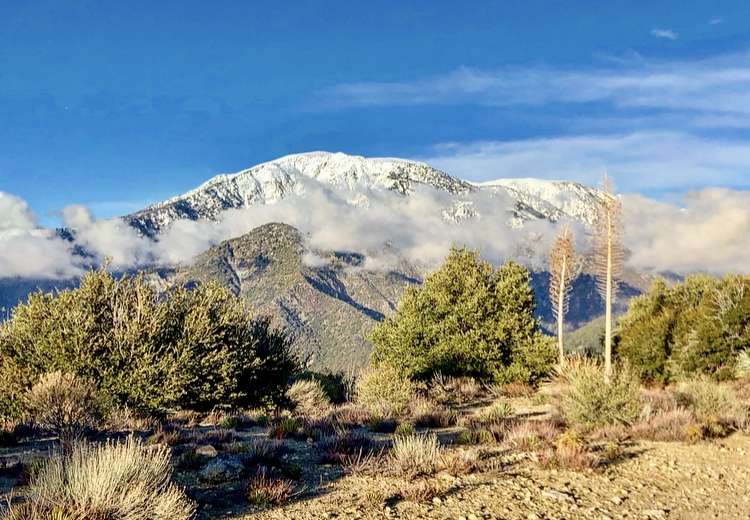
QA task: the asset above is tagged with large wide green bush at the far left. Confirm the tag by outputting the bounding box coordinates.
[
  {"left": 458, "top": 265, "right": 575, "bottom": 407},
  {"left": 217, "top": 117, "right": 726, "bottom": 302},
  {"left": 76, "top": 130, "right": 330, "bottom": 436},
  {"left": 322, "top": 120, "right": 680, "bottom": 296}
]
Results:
[{"left": 0, "top": 270, "right": 298, "bottom": 415}]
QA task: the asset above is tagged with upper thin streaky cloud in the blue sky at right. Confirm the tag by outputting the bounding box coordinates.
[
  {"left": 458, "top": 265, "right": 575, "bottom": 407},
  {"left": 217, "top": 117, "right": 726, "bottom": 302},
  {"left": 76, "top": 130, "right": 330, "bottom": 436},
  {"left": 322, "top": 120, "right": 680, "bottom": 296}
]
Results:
[{"left": 319, "top": 53, "right": 750, "bottom": 127}]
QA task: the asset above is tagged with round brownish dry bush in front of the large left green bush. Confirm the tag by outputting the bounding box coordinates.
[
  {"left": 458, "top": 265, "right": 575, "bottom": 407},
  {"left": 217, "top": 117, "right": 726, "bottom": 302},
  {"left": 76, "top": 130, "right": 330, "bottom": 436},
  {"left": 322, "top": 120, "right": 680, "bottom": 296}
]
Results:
[{"left": 25, "top": 371, "right": 102, "bottom": 446}]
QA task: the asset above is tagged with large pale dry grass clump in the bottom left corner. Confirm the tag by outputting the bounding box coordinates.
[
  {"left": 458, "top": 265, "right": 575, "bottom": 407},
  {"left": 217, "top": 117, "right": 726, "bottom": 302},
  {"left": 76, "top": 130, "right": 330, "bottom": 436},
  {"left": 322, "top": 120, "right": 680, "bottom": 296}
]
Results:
[{"left": 2, "top": 437, "right": 195, "bottom": 520}]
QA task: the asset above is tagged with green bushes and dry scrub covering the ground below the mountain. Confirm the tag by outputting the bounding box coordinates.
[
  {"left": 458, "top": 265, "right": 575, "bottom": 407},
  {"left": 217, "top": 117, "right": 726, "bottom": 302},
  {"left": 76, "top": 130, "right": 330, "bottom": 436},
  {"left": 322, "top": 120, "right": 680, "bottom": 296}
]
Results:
[{"left": 0, "top": 249, "right": 750, "bottom": 520}]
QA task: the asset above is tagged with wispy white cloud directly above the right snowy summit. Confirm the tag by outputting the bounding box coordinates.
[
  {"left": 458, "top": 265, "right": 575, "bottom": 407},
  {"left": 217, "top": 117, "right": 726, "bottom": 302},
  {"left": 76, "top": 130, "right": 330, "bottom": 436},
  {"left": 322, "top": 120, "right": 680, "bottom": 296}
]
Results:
[{"left": 420, "top": 132, "right": 750, "bottom": 192}]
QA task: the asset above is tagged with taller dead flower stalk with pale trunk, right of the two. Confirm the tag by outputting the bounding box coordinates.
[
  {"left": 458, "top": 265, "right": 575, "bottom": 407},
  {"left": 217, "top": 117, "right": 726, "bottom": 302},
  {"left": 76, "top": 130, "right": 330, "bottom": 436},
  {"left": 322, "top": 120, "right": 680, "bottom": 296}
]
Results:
[{"left": 594, "top": 174, "right": 624, "bottom": 381}]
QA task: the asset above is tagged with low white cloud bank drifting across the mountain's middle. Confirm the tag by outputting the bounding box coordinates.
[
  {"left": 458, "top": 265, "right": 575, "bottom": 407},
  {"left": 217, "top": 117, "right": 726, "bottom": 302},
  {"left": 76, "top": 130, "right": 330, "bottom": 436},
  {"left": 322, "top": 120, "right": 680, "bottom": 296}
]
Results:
[{"left": 0, "top": 184, "right": 750, "bottom": 278}]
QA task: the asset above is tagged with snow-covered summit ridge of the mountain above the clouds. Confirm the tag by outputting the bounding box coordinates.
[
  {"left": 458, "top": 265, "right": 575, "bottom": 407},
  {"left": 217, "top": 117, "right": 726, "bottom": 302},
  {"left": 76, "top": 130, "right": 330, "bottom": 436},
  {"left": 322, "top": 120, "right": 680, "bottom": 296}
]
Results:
[{"left": 125, "top": 152, "right": 600, "bottom": 236}]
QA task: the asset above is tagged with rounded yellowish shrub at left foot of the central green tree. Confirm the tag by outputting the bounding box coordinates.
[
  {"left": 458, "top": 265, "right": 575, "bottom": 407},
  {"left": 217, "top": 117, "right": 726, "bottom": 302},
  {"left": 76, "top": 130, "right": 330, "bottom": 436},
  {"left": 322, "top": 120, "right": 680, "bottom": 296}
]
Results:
[{"left": 355, "top": 366, "right": 414, "bottom": 417}]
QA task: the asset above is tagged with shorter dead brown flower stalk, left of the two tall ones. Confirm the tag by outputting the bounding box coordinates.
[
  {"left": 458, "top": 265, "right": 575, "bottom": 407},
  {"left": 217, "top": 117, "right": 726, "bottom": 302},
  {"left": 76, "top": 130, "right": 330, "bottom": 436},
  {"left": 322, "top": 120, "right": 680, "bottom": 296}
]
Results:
[{"left": 549, "top": 226, "right": 578, "bottom": 365}]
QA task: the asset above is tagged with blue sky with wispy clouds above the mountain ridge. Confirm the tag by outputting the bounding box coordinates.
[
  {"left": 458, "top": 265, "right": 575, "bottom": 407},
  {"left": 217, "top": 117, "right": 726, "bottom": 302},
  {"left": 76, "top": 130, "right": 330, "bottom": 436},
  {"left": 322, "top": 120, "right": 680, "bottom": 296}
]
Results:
[{"left": 0, "top": 0, "right": 750, "bottom": 223}]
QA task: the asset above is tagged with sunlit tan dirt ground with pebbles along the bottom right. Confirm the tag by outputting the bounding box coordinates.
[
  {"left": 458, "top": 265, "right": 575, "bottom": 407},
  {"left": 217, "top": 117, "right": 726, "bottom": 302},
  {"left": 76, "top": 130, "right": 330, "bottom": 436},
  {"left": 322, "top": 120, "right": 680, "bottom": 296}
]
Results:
[{"left": 245, "top": 435, "right": 750, "bottom": 520}]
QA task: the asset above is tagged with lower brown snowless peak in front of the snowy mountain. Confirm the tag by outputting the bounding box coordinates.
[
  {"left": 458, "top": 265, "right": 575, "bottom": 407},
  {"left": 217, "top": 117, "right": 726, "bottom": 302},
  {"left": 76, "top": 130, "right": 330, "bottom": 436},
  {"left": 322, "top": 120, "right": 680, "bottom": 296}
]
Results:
[{"left": 167, "top": 223, "right": 421, "bottom": 371}]
